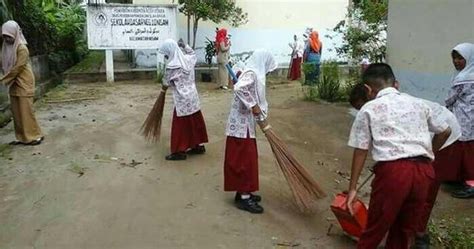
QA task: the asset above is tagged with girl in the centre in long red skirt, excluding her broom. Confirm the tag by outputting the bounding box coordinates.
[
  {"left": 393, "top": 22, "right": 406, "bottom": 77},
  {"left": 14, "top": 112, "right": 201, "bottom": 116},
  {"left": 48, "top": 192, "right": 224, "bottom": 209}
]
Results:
[{"left": 224, "top": 50, "right": 277, "bottom": 213}]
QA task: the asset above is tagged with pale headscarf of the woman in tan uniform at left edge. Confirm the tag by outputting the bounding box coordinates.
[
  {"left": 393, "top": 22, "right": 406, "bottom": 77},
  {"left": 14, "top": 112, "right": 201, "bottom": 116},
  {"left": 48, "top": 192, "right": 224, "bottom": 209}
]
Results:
[{"left": 2, "top": 21, "right": 27, "bottom": 74}]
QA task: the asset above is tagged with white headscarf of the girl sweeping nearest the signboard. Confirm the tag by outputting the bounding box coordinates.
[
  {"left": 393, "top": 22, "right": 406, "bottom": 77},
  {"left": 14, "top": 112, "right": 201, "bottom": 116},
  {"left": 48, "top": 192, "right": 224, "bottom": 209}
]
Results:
[{"left": 159, "top": 39, "right": 193, "bottom": 73}]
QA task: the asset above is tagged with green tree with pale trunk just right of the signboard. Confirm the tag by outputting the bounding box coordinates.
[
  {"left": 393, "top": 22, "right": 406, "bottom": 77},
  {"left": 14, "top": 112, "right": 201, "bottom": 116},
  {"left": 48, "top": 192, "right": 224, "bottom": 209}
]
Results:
[{"left": 178, "top": 0, "right": 248, "bottom": 48}]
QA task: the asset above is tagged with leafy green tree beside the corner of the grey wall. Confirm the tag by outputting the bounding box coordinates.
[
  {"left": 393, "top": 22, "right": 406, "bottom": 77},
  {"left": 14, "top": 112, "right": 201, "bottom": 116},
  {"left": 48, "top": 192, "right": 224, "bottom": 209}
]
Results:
[{"left": 328, "top": 0, "right": 388, "bottom": 62}]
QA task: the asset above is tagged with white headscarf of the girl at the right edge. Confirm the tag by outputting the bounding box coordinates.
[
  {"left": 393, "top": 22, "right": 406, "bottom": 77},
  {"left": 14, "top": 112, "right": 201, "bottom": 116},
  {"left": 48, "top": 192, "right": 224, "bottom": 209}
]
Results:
[{"left": 452, "top": 43, "right": 474, "bottom": 86}]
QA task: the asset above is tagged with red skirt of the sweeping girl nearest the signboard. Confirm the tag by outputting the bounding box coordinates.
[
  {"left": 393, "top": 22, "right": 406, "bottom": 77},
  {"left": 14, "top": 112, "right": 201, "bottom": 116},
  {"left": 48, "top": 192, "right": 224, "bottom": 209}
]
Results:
[{"left": 171, "top": 110, "right": 208, "bottom": 153}]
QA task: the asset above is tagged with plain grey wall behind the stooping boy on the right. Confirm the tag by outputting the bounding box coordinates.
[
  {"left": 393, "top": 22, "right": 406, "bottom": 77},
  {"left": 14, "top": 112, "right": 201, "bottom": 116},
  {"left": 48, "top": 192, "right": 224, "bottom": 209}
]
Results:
[{"left": 387, "top": 0, "right": 474, "bottom": 103}]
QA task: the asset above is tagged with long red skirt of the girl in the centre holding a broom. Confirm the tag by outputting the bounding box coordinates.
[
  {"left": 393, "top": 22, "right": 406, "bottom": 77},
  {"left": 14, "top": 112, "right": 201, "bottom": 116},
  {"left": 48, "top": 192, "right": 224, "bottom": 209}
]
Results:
[{"left": 224, "top": 136, "right": 258, "bottom": 193}]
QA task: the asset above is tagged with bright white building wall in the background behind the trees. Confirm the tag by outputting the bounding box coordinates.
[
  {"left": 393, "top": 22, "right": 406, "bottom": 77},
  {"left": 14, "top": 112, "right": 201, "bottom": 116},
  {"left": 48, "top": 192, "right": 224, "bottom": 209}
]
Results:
[{"left": 134, "top": 0, "right": 348, "bottom": 64}]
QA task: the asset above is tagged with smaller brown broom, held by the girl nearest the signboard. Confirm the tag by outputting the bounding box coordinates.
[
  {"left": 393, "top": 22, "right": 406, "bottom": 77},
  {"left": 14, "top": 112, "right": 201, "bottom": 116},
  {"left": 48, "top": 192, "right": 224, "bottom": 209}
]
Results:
[{"left": 140, "top": 91, "right": 166, "bottom": 142}]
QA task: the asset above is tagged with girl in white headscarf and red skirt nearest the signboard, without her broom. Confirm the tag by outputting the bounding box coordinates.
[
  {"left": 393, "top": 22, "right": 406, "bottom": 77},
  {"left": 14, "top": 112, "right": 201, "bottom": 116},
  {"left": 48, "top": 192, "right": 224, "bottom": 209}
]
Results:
[{"left": 160, "top": 39, "right": 208, "bottom": 161}]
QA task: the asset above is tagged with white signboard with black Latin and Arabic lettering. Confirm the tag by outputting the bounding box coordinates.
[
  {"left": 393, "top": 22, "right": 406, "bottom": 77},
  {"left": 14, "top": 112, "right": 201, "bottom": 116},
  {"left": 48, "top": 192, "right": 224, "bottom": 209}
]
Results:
[{"left": 87, "top": 4, "right": 176, "bottom": 50}]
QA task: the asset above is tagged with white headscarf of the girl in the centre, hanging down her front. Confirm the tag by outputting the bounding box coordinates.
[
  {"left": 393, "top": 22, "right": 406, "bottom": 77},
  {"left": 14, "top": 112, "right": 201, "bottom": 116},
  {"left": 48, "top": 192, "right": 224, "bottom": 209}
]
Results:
[{"left": 244, "top": 49, "right": 278, "bottom": 118}]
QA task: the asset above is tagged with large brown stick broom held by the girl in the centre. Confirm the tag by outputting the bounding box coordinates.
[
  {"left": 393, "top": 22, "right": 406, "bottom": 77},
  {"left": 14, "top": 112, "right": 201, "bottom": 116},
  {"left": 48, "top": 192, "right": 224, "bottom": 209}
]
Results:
[{"left": 259, "top": 122, "right": 326, "bottom": 213}]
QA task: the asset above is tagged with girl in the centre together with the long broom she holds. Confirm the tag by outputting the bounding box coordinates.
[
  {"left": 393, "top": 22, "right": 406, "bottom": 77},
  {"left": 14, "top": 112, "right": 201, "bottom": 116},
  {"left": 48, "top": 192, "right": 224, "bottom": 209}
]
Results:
[{"left": 224, "top": 50, "right": 325, "bottom": 213}]
